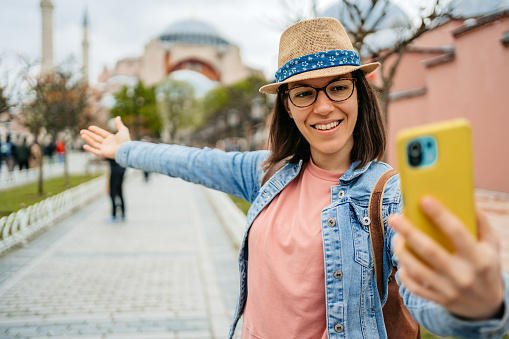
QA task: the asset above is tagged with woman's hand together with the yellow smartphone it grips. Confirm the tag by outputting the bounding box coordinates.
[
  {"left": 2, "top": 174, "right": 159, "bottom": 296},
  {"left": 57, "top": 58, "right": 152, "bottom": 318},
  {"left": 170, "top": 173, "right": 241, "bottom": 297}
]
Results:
[{"left": 389, "top": 120, "right": 507, "bottom": 320}]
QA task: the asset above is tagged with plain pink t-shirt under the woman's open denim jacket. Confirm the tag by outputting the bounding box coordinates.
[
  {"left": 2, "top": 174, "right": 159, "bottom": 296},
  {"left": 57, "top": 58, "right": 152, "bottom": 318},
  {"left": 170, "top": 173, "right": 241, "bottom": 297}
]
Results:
[{"left": 242, "top": 162, "right": 341, "bottom": 339}]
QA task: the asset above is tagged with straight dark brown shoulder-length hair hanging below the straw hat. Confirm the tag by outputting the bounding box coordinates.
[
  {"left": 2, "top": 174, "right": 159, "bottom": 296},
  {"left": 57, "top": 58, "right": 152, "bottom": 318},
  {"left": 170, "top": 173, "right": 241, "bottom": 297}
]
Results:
[{"left": 263, "top": 70, "right": 387, "bottom": 169}]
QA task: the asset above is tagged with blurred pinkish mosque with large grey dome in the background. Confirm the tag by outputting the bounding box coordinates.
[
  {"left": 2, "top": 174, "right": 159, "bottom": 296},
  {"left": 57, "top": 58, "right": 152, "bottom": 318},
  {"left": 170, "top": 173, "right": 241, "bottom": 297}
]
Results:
[{"left": 99, "top": 20, "right": 263, "bottom": 86}]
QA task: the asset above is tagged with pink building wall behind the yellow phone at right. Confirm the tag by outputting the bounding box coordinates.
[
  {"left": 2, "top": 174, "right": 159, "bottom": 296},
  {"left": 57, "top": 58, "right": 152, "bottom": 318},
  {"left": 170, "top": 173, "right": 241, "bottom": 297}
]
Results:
[{"left": 387, "top": 11, "right": 509, "bottom": 192}]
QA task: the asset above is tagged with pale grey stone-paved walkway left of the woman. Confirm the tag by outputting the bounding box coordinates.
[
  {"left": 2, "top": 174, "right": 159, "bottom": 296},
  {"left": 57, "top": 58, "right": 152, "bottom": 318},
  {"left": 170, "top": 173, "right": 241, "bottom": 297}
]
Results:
[{"left": 0, "top": 174, "right": 242, "bottom": 339}]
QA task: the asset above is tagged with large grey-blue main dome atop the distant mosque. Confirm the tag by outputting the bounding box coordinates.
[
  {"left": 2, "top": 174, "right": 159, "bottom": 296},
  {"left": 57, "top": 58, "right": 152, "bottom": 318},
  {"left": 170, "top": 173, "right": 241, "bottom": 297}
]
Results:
[{"left": 159, "top": 20, "right": 230, "bottom": 46}]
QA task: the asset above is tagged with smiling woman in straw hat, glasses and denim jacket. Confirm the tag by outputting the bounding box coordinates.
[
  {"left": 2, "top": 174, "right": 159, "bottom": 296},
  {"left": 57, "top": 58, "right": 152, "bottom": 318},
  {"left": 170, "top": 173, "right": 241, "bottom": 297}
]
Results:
[{"left": 82, "top": 18, "right": 509, "bottom": 339}]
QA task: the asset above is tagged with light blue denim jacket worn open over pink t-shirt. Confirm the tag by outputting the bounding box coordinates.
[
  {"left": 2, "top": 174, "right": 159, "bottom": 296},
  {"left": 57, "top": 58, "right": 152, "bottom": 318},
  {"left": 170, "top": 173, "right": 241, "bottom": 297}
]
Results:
[{"left": 116, "top": 142, "right": 509, "bottom": 339}]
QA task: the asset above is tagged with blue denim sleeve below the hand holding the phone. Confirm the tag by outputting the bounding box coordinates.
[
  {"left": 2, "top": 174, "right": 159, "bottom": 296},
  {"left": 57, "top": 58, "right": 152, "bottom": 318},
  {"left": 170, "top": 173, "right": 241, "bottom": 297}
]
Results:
[{"left": 386, "top": 208, "right": 509, "bottom": 339}]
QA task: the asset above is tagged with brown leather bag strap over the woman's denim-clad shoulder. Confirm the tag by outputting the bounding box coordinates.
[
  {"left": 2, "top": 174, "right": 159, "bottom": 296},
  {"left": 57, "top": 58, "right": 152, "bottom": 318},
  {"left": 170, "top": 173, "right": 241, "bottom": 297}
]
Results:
[{"left": 368, "top": 169, "right": 398, "bottom": 298}]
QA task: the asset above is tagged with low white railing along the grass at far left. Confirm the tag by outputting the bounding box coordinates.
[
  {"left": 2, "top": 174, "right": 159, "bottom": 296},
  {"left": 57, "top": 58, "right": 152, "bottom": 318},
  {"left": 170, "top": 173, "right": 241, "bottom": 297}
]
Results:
[{"left": 0, "top": 175, "right": 106, "bottom": 254}]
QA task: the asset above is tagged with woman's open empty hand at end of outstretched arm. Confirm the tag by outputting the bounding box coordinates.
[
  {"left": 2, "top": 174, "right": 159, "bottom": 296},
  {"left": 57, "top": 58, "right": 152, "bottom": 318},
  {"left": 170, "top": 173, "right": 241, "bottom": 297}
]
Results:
[{"left": 80, "top": 117, "right": 131, "bottom": 159}]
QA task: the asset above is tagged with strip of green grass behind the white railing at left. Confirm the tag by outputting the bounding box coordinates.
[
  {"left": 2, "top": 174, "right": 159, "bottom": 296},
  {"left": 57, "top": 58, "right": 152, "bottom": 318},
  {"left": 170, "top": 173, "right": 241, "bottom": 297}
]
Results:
[{"left": 0, "top": 174, "right": 100, "bottom": 218}]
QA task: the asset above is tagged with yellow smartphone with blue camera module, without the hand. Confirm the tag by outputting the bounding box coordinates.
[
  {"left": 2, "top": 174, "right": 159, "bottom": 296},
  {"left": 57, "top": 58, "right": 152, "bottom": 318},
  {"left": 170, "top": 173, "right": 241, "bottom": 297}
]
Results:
[{"left": 396, "top": 119, "right": 477, "bottom": 253}]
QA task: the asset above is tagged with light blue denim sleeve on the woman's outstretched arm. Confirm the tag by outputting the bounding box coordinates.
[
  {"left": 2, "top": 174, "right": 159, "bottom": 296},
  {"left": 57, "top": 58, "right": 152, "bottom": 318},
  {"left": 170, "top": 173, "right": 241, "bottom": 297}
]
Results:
[{"left": 115, "top": 141, "right": 268, "bottom": 202}]
